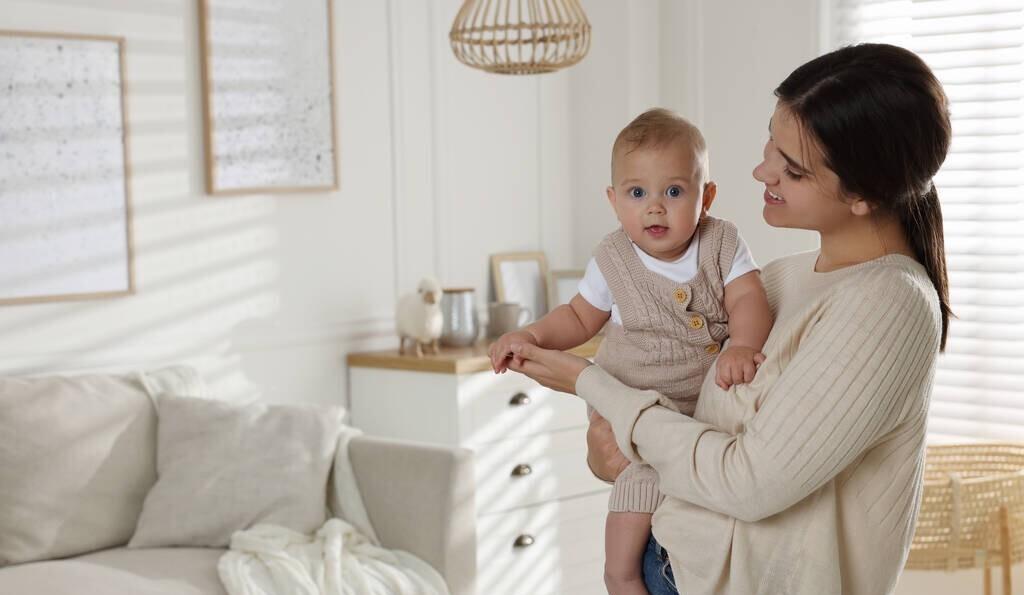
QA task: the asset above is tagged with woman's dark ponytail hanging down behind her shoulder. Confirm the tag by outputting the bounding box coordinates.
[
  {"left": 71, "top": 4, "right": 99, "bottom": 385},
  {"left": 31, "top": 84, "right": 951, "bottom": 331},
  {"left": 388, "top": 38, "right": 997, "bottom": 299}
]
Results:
[{"left": 899, "top": 183, "right": 952, "bottom": 351}]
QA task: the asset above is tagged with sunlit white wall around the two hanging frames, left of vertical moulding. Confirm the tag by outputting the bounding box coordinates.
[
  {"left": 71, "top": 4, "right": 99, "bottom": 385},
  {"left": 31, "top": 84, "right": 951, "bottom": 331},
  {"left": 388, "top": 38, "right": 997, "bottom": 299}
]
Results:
[{"left": 0, "top": 0, "right": 396, "bottom": 400}]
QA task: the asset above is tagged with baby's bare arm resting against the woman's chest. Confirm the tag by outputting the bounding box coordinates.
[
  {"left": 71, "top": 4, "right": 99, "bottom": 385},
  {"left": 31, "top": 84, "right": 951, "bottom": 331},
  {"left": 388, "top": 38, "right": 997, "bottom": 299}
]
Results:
[{"left": 716, "top": 270, "right": 772, "bottom": 389}]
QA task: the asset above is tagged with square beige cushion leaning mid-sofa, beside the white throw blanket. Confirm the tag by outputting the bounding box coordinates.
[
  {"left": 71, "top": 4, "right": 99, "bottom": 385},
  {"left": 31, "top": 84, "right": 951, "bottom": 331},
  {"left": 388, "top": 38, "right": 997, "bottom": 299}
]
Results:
[{"left": 129, "top": 394, "right": 343, "bottom": 547}]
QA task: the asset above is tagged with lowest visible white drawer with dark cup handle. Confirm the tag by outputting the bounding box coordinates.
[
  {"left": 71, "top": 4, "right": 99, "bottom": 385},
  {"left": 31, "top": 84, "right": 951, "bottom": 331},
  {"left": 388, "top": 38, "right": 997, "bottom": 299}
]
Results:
[{"left": 476, "top": 490, "right": 608, "bottom": 595}]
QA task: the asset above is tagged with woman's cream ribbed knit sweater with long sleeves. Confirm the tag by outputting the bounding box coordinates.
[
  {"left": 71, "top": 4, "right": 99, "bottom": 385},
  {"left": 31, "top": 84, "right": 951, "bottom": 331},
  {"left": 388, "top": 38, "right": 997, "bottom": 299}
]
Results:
[{"left": 577, "top": 252, "right": 941, "bottom": 595}]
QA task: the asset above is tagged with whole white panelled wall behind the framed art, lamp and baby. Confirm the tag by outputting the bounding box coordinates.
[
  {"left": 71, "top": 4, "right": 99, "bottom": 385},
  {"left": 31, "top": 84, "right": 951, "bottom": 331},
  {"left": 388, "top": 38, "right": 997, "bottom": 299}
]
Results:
[{"left": 0, "top": 0, "right": 813, "bottom": 402}]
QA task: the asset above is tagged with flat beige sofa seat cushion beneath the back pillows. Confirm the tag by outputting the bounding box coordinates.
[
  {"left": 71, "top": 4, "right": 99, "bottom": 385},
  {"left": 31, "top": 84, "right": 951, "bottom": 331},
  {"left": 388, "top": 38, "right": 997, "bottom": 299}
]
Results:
[{"left": 0, "top": 548, "right": 226, "bottom": 595}]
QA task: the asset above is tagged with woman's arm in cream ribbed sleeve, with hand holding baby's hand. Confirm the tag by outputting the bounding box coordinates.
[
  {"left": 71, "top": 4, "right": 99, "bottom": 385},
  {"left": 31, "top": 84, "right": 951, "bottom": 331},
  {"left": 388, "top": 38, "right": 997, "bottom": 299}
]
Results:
[{"left": 522, "top": 268, "right": 939, "bottom": 521}]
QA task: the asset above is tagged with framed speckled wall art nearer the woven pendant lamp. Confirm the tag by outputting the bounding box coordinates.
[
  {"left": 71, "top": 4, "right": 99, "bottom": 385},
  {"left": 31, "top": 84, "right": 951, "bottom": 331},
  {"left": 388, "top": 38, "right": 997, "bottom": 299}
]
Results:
[{"left": 200, "top": 0, "right": 338, "bottom": 195}]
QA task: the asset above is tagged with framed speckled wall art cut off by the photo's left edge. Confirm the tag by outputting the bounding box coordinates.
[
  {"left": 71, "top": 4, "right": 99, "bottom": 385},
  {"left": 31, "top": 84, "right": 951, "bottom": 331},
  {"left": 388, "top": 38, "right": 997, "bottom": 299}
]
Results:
[{"left": 0, "top": 31, "right": 134, "bottom": 304}]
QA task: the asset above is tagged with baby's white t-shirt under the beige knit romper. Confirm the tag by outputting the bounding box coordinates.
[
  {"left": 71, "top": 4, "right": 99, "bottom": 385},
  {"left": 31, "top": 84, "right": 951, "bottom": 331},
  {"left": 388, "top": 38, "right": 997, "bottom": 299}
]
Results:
[{"left": 580, "top": 235, "right": 760, "bottom": 325}]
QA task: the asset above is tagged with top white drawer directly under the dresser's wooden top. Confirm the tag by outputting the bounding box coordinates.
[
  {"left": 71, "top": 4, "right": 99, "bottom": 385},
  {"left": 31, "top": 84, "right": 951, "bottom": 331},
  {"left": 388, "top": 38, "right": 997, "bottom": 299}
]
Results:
[{"left": 459, "top": 372, "right": 587, "bottom": 447}]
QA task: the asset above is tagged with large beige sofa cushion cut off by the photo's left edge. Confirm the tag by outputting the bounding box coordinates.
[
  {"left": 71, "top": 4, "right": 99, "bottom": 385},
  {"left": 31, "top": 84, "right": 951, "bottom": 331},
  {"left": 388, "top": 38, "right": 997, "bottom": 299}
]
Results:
[{"left": 0, "top": 368, "right": 202, "bottom": 565}]
